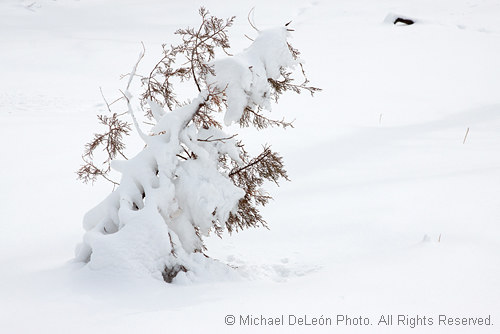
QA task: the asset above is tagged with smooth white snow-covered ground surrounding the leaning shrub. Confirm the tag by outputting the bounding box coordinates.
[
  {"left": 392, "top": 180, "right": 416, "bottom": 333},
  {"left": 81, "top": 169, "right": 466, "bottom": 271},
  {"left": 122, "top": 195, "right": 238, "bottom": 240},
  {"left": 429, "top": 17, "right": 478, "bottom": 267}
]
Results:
[{"left": 0, "top": 0, "right": 500, "bottom": 334}]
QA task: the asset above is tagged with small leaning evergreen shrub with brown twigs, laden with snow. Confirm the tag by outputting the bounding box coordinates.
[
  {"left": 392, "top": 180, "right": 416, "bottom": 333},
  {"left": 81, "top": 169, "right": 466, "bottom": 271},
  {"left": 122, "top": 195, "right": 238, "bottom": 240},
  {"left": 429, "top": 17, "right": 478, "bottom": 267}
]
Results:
[{"left": 76, "top": 8, "right": 318, "bottom": 282}]
